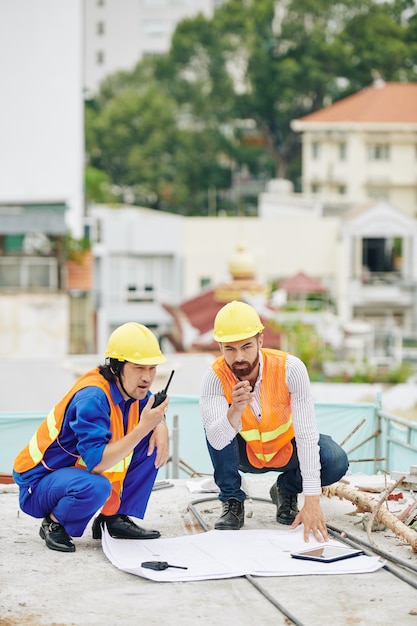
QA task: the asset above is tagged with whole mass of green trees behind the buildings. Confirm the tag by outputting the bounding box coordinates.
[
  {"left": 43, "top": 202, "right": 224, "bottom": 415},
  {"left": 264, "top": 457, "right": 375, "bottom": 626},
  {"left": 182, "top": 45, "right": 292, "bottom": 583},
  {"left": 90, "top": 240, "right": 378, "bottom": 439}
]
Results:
[{"left": 86, "top": 0, "right": 417, "bottom": 215}]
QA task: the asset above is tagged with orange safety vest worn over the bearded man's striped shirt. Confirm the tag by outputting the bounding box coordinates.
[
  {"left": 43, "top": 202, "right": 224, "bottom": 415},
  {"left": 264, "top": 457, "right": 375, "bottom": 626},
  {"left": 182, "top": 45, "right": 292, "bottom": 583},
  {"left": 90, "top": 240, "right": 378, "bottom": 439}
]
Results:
[{"left": 212, "top": 348, "right": 294, "bottom": 468}]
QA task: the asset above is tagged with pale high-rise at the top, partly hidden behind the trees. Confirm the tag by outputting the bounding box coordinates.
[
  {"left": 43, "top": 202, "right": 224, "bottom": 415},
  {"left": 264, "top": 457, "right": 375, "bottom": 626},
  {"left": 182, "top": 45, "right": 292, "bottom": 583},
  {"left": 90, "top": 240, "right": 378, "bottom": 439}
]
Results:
[{"left": 84, "top": 0, "right": 221, "bottom": 96}]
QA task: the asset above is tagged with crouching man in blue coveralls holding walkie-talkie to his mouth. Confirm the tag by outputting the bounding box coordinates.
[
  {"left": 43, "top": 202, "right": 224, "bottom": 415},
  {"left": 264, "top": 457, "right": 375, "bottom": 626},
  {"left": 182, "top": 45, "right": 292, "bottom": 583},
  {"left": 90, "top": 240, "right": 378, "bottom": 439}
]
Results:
[{"left": 13, "top": 322, "right": 168, "bottom": 552}]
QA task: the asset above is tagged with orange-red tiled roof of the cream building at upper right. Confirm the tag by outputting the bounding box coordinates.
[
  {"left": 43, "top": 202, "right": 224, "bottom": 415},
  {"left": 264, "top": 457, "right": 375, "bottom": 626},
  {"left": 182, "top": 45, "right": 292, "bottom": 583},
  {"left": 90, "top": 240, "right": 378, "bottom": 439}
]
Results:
[{"left": 299, "top": 83, "right": 417, "bottom": 123}]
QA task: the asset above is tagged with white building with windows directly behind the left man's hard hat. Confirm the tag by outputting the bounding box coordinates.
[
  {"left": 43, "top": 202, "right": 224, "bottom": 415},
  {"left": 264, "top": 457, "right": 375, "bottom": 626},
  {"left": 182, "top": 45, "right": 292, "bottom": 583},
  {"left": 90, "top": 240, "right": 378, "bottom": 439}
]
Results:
[{"left": 90, "top": 206, "right": 185, "bottom": 353}]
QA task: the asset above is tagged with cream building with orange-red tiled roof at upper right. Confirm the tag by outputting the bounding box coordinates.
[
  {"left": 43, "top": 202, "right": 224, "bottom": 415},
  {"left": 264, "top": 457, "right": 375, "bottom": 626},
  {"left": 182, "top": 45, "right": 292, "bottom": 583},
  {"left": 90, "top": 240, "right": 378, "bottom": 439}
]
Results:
[{"left": 292, "top": 81, "right": 417, "bottom": 217}]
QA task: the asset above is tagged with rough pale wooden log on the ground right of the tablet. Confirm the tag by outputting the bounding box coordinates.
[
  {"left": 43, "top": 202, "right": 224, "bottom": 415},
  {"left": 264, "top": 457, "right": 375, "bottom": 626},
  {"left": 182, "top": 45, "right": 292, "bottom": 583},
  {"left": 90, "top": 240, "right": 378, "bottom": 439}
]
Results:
[{"left": 322, "top": 482, "right": 417, "bottom": 552}]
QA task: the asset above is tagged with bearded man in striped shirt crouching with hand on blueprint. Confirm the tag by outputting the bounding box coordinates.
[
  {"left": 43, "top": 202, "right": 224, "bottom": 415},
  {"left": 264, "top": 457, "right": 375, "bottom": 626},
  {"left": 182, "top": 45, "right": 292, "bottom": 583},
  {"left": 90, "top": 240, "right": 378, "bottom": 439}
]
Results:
[{"left": 200, "top": 301, "right": 348, "bottom": 541}]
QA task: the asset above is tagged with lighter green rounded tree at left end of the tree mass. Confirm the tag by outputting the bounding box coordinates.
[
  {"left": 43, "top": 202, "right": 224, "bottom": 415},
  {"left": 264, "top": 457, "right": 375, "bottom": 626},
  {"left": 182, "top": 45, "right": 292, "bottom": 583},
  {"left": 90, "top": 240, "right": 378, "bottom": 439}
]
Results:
[{"left": 86, "top": 59, "right": 234, "bottom": 215}]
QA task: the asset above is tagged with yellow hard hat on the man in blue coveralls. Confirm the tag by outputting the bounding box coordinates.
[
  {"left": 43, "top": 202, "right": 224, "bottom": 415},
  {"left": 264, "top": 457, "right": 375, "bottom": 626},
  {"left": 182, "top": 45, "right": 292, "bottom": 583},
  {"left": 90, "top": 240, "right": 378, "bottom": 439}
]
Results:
[{"left": 105, "top": 322, "right": 166, "bottom": 365}]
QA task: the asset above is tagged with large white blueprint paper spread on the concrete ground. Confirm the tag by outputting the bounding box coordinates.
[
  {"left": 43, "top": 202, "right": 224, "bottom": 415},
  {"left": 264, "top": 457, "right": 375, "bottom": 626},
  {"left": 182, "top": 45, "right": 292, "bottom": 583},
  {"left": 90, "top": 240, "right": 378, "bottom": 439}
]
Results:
[{"left": 102, "top": 528, "right": 384, "bottom": 582}]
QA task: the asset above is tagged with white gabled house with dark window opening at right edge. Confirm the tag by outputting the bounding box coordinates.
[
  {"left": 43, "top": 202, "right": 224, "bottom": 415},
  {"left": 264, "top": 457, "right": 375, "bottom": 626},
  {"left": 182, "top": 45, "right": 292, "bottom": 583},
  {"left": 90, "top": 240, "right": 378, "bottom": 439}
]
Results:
[{"left": 337, "top": 201, "right": 417, "bottom": 364}]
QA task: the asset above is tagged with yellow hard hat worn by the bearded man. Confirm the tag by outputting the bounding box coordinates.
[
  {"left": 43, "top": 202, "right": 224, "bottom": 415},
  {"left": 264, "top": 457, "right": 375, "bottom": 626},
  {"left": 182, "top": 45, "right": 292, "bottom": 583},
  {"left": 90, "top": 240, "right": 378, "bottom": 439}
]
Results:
[{"left": 213, "top": 300, "right": 264, "bottom": 343}]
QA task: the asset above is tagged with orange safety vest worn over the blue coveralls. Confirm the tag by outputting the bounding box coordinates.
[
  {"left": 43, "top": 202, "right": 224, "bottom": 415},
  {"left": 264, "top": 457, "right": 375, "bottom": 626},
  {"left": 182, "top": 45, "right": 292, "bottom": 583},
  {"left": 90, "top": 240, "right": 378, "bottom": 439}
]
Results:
[{"left": 14, "top": 368, "right": 139, "bottom": 515}]
